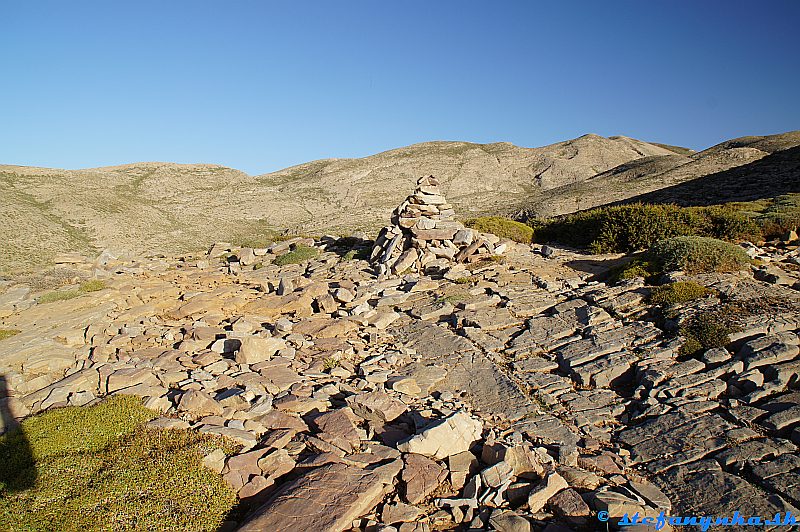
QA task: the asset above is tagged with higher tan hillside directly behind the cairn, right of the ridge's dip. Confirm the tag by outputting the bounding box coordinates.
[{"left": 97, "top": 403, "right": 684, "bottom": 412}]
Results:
[{"left": 258, "top": 135, "right": 672, "bottom": 229}]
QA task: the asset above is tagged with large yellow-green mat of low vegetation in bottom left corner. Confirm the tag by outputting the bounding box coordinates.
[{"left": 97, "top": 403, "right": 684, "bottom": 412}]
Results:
[{"left": 0, "top": 396, "right": 236, "bottom": 531}]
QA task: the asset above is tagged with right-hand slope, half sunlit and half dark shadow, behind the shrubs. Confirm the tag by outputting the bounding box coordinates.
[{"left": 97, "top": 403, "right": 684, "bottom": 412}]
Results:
[{"left": 525, "top": 131, "right": 800, "bottom": 217}]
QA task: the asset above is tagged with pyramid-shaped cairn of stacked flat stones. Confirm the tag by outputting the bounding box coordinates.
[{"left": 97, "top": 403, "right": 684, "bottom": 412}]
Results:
[{"left": 370, "top": 176, "right": 503, "bottom": 275}]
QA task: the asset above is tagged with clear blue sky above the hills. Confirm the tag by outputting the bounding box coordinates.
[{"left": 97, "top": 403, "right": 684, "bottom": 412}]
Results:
[{"left": 0, "top": 0, "right": 800, "bottom": 174}]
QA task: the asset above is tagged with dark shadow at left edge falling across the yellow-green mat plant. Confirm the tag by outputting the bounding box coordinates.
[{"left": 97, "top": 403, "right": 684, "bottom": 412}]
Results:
[{"left": 0, "top": 375, "right": 37, "bottom": 493}]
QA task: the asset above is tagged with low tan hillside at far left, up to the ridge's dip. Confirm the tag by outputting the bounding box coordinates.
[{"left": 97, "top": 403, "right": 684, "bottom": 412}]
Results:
[{"left": 0, "top": 163, "right": 266, "bottom": 270}]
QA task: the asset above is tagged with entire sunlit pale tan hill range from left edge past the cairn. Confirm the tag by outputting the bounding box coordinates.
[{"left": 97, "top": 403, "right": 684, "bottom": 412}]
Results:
[{"left": 0, "top": 135, "right": 670, "bottom": 271}]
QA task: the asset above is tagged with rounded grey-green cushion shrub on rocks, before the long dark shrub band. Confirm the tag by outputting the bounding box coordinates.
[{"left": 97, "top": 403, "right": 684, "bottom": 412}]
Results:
[{"left": 648, "top": 236, "right": 750, "bottom": 273}]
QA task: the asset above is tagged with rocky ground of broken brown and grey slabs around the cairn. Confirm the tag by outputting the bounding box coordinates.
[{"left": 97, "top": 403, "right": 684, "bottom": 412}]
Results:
[{"left": 0, "top": 238, "right": 800, "bottom": 532}]
